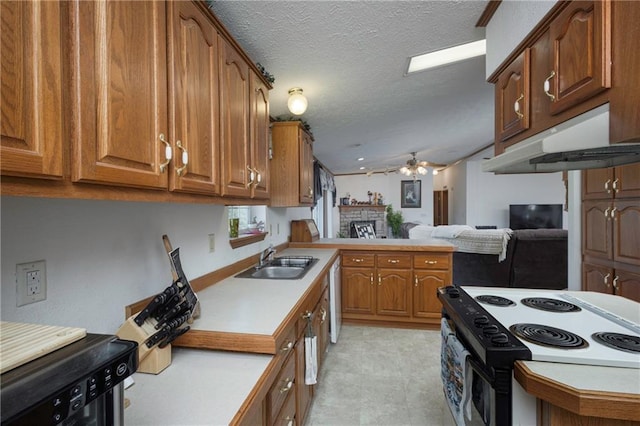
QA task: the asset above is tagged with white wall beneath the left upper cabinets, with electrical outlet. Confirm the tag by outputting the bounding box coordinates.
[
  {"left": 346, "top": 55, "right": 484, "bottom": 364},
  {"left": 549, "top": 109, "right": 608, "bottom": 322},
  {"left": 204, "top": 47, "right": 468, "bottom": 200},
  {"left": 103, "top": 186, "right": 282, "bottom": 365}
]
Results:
[{"left": 1, "top": 196, "right": 311, "bottom": 333}]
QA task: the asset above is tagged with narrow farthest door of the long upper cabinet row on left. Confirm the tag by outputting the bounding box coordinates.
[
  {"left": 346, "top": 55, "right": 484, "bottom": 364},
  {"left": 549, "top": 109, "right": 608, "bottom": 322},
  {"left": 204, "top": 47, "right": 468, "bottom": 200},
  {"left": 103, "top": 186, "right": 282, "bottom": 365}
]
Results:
[{"left": 250, "top": 73, "right": 270, "bottom": 199}]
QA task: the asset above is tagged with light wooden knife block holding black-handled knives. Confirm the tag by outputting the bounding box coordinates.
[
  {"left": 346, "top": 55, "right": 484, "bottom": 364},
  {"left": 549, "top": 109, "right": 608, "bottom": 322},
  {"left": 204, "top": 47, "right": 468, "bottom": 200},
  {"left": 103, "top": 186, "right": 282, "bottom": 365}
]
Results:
[{"left": 116, "top": 314, "right": 171, "bottom": 374}]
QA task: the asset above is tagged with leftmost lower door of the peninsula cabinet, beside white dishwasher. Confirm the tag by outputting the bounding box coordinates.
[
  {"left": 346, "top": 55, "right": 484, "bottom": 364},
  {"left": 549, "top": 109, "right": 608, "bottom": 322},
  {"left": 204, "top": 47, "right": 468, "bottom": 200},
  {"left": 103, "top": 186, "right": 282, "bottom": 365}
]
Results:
[{"left": 341, "top": 266, "right": 375, "bottom": 315}]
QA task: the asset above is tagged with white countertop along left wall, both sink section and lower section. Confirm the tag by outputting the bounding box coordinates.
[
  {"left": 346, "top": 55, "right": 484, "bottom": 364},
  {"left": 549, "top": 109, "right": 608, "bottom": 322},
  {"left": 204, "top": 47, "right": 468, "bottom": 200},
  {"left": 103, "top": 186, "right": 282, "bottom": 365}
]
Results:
[{"left": 125, "top": 248, "right": 337, "bottom": 426}]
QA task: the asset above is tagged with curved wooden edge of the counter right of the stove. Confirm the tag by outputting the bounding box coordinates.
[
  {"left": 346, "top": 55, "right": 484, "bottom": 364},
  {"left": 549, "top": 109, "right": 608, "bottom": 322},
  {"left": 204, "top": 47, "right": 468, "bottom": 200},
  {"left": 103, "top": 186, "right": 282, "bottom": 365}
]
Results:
[{"left": 514, "top": 361, "right": 640, "bottom": 421}]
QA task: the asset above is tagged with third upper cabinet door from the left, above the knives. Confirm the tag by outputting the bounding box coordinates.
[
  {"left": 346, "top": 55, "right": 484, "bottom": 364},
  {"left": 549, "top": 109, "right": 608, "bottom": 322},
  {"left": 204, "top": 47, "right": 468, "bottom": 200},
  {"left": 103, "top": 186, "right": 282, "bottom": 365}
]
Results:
[{"left": 167, "top": 2, "right": 220, "bottom": 194}]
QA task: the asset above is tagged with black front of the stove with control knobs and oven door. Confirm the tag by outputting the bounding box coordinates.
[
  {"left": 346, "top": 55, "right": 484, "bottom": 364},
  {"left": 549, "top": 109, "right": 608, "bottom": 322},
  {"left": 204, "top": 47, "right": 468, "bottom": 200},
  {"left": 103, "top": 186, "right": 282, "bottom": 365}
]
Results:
[{"left": 437, "top": 286, "right": 531, "bottom": 426}]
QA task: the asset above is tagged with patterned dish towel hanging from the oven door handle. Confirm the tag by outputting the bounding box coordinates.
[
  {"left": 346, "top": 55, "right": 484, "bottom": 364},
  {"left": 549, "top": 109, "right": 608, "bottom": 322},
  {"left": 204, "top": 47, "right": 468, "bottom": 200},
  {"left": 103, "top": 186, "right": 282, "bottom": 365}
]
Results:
[{"left": 440, "top": 318, "right": 473, "bottom": 426}]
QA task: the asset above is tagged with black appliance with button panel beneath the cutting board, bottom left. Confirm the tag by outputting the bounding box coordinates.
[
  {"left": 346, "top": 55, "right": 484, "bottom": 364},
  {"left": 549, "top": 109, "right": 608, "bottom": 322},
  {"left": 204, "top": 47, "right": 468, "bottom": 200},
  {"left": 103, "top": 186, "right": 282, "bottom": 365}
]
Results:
[{"left": 0, "top": 334, "right": 138, "bottom": 426}]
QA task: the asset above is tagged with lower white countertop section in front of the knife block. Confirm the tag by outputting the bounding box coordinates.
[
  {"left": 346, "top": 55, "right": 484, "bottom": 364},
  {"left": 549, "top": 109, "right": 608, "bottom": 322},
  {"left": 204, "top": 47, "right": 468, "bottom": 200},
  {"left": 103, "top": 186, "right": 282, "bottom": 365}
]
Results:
[{"left": 124, "top": 348, "right": 273, "bottom": 426}]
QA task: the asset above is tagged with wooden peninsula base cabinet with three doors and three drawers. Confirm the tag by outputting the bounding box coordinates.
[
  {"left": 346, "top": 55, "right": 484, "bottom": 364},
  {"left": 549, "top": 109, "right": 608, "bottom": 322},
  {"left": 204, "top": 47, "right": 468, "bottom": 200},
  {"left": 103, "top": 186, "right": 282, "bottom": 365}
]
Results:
[{"left": 341, "top": 251, "right": 452, "bottom": 325}]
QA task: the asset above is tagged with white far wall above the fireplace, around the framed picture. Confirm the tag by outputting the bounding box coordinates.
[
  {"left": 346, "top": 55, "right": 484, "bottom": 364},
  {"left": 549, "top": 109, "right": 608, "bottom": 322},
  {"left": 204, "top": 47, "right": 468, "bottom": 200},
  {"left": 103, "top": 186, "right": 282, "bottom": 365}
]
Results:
[{"left": 333, "top": 173, "right": 433, "bottom": 236}]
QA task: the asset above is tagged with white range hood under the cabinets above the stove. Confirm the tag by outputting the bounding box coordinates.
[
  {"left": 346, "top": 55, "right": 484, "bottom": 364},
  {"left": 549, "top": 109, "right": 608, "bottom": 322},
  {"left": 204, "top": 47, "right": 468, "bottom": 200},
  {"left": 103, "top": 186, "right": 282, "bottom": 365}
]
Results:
[{"left": 482, "top": 104, "right": 640, "bottom": 174}]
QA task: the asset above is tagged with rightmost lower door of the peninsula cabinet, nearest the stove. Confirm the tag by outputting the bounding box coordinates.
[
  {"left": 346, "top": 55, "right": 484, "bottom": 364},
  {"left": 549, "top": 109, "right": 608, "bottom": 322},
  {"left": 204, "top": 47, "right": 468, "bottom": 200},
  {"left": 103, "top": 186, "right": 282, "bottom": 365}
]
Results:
[{"left": 412, "top": 271, "right": 451, "bottom": 318}]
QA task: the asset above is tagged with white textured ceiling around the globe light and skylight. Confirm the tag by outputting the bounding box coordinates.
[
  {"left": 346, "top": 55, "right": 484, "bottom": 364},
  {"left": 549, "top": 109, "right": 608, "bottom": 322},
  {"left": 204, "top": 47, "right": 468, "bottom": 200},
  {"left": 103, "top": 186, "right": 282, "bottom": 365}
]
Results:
[{"left": 210, "top": 1, "right": 494, "bottom": 174}]
